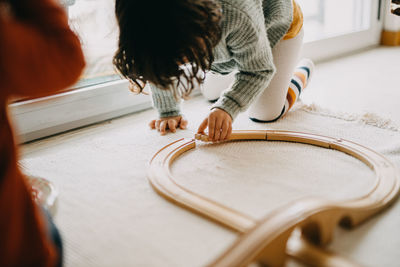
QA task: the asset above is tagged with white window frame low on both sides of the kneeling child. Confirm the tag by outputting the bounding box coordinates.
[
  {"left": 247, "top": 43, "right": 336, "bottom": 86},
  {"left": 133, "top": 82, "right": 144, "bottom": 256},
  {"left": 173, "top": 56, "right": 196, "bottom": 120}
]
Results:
[{"left": 9, "top": 0, "right": 386, "bottom": 143}]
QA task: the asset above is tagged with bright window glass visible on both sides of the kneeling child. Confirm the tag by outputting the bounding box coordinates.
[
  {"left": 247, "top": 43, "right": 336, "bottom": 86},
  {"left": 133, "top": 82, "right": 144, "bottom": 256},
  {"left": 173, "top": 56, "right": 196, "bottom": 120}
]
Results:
[{"left": 64, "top": 0, "right": 372, "bottom": 88}]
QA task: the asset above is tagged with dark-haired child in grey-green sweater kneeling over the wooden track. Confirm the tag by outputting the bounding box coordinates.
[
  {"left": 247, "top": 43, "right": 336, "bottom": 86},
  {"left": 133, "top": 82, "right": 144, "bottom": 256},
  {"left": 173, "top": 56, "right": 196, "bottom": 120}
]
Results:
[{"left": 114, "top": 0, "right": 313, "bottom": 141}]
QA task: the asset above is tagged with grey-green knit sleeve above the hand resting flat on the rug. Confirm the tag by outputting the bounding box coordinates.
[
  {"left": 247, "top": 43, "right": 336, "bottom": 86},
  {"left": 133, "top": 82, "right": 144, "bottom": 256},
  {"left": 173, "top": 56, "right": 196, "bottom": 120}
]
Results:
[{"left": 150, "top": 84, "right": 181, "bottom": 118}]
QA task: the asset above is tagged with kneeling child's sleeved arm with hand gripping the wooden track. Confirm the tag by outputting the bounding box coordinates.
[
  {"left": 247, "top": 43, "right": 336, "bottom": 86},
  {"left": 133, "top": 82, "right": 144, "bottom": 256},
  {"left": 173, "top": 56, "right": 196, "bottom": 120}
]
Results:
[{"left": 198, "top": 8, "right": 275, "bottom": 141}]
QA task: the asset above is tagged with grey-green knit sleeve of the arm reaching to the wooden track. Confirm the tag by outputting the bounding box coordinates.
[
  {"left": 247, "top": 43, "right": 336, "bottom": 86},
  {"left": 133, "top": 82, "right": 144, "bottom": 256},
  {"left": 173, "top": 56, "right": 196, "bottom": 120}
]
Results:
[{"left": 212, "top": 4, "right": 275, "bottom": 119}]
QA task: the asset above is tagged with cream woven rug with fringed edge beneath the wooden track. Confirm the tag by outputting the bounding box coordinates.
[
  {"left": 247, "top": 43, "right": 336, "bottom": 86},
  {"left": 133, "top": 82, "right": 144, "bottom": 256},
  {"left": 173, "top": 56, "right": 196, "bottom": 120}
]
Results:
[{"left": 22, "top": 98, "right": 400, "bottom": 267}]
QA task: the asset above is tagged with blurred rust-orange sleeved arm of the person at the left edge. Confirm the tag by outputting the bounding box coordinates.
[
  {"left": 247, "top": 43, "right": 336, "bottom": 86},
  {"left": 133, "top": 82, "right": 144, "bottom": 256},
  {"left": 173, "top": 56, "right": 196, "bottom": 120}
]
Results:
[{"left": 0, "top": 0, "right": 85, "bottom": 97}]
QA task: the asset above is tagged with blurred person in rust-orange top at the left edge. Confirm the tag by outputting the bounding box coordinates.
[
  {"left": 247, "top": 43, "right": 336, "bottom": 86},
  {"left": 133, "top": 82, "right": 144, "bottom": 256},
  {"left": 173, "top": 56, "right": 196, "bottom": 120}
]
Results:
[{"left": 0, "top": 0, "right": 84, "bottom": 267}]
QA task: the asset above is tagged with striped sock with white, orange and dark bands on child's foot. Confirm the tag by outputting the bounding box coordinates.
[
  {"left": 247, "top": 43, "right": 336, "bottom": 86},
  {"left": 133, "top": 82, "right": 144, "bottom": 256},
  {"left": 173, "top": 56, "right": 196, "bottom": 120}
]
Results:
[{"left": 282, "top": 59, "right": 314, "bottom": 116}]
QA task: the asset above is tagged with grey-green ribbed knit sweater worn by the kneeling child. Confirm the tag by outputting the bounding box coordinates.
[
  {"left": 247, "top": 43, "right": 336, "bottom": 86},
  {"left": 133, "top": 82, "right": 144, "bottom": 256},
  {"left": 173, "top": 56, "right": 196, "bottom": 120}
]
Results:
[{"left": 151, "top": 0, "right": 293, "bottom": 119}]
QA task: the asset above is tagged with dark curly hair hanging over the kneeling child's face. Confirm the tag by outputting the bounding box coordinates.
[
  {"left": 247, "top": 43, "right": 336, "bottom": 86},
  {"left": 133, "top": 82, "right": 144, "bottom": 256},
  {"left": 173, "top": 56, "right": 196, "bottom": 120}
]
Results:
[{"left": 113, "top": 0, "right": 222, "bottom": 96}]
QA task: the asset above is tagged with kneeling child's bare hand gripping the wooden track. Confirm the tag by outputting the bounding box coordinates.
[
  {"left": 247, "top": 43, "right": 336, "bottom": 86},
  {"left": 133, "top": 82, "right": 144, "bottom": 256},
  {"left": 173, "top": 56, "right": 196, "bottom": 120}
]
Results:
[{"left": 197, "top": 108, "right": 232, "bottom": 142}]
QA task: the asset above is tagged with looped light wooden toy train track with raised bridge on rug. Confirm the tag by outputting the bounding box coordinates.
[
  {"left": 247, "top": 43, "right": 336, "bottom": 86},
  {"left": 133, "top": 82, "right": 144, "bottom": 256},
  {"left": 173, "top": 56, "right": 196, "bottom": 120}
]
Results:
[{"left": 148, "top": 130, "right": 400, "bottom": 267}]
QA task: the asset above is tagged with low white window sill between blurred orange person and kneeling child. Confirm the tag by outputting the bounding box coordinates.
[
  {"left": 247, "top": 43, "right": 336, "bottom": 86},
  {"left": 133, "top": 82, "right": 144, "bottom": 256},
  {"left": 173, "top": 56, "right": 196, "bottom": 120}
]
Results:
[{"left": 9, "top": 81, "right": 151, "bottom": 143}]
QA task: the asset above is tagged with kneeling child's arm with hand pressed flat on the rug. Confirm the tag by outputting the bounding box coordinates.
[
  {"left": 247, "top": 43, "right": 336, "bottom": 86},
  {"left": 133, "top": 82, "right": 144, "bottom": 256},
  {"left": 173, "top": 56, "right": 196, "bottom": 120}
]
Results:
[{"left": 149, "top": 84, "right": 188, "bottom": 135}]
